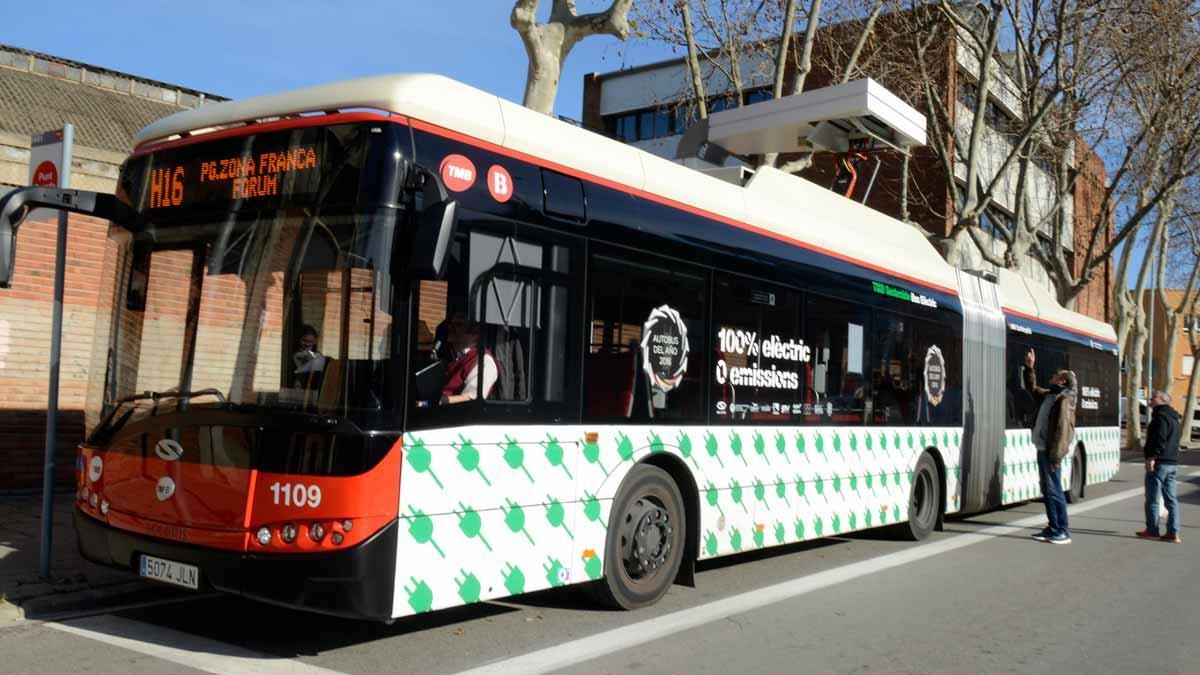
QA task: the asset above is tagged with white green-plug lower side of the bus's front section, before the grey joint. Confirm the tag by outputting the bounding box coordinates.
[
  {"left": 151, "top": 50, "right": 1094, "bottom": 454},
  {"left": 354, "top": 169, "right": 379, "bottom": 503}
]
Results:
[{"left": 394, "top": 425, "right": 962, "bottom": 616}]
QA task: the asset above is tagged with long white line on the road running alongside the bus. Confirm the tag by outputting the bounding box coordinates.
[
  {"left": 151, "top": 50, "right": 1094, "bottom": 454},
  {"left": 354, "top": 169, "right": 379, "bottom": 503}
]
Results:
[{"left": 460, "top": 471, "right": 1200, "bottom": 675}]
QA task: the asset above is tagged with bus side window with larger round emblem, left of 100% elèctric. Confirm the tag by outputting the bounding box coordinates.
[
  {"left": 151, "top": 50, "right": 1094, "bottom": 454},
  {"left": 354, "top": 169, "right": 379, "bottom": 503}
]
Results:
[{"left": 583, "top": 252, "right": 708, "bottom": 422}]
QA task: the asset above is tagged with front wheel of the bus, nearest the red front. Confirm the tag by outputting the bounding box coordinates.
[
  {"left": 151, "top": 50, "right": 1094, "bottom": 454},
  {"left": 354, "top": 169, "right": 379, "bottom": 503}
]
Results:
[{"left": 595, "top": 464, "right": 688, "bottom": 609}]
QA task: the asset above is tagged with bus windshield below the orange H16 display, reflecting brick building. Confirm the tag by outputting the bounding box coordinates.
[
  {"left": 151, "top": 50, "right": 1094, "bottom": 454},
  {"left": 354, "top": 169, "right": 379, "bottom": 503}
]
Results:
[{"left": 95, "top": 209, "right": 392, "bottom": 432}]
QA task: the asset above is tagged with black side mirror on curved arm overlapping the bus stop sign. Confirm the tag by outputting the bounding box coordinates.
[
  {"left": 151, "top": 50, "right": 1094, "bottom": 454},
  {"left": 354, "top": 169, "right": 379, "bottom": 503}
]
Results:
[{"left": 0, "top": 187, "right": 138, "bottom": 288}]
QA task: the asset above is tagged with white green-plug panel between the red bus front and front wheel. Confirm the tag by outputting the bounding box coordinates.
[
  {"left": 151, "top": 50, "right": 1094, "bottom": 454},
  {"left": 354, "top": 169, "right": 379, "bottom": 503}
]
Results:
[{"left": 394, "top": 425, "right": 588, "bottom": 616}]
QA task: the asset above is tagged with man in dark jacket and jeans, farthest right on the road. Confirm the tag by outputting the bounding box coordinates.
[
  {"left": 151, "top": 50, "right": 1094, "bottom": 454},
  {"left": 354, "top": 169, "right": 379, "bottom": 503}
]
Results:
[{"left": 1138, "top": 392, "right": 1183, "bottom": 544}]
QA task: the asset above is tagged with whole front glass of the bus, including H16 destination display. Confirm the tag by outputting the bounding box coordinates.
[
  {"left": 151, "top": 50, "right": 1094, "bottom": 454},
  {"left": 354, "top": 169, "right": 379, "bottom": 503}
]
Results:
[{"left": 96, "top": 120, "right": 408, "bottom": 438}]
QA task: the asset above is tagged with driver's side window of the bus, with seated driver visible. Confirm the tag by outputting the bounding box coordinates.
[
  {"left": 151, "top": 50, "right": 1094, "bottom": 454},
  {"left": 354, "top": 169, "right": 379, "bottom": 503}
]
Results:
[{"left": 412, "top": 221, "right": 577, "bottom": 423}]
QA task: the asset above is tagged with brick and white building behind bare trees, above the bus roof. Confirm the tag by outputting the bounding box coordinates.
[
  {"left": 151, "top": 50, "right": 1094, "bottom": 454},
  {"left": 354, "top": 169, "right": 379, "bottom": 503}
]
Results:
[{"left": 583, "top": 10, "right": 1112, "bottom": 321}]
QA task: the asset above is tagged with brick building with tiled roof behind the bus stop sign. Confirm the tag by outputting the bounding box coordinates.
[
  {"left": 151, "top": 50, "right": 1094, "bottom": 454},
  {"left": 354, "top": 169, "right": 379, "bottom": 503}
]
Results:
[{"left": 0, "top": 46, "right": 224, "bottom": 491}]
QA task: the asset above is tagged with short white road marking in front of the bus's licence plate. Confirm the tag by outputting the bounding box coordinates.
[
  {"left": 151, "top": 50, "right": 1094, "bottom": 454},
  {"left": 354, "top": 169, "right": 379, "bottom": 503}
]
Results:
[{"left": 43, "top": 615, "right": 348, "bottom": 675}]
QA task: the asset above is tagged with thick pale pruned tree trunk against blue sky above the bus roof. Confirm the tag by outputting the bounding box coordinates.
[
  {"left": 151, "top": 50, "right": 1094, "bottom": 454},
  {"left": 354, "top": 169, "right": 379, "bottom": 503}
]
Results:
[{"left": 510, "top": 0, "right": 634, "bottom": 115}]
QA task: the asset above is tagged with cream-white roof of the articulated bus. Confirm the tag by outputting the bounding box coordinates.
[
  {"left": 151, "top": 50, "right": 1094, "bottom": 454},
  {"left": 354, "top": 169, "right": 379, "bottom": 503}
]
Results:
[{"left": 134, "top": 73, "right": 1115, "bottom": 338}]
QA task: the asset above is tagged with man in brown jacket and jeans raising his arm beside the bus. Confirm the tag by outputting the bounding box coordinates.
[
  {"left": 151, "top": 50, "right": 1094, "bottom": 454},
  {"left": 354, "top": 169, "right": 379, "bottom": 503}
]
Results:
[{"left": 1022, "top": 351, "right": 1075, "bottom": 544}]
